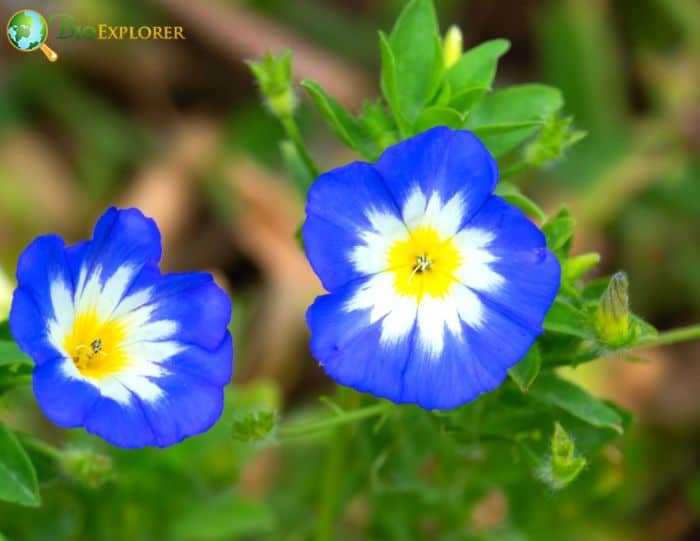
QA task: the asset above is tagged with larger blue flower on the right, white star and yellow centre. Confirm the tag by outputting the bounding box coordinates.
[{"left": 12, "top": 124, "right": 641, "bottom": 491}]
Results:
[{"left": 303, "top": 128, "right": 561, "bottom": 409}]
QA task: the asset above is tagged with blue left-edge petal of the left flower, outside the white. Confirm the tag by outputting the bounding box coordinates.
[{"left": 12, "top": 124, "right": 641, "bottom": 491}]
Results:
[{"left": 10, "top": 235, "right": 73, "bottom": 364}]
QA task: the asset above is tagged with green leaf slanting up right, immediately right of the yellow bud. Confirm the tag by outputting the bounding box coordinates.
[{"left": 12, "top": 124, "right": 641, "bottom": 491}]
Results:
[{"left": 446, "top": 39, "right": 510, "bottom": 113}]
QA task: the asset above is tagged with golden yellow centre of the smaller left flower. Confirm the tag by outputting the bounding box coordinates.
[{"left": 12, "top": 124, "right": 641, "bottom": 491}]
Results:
[{"left": 63, "top": 311, "right": 128, "bottom": 380}]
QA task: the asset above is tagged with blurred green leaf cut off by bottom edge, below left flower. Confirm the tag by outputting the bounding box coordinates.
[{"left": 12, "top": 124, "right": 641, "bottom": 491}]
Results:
[{"left": 171, "top": 496, "right": 275, "bottom": 541}]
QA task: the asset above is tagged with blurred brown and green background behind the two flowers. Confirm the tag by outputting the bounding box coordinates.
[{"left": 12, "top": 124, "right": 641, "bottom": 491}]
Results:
[{"left": 0, "top": 0, "right": 700, "bottom": 541}]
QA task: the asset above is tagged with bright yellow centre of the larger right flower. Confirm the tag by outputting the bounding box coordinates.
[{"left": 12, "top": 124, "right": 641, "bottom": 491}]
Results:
[{"left": 388, "top": 227, "right": 462, "bottom": 301}]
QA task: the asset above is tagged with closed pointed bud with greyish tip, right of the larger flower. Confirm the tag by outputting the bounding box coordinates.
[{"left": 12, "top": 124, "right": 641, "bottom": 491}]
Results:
[{"left": 595, "top": 272, "right": 634, "bottom": 348}]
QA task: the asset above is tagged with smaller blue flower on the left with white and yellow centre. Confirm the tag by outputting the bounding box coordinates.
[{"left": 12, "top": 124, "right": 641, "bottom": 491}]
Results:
[{"left": 10, "top": 208, "right": 233, "bottom": 447}]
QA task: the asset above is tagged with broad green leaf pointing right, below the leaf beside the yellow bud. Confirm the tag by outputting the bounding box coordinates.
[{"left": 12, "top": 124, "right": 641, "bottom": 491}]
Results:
[{"left": 467, "top": 84, "right": 564, "bottom": 157}]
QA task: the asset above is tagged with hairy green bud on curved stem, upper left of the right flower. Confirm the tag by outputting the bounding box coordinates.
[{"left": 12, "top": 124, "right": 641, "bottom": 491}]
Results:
[{"left": 248, "top": 50, "right": 297, "bottom": 118}]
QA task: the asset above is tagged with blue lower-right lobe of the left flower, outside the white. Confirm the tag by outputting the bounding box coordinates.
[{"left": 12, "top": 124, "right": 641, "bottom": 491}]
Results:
[{"left": 142, "top": 333, "right": 232, "bottom": 447}]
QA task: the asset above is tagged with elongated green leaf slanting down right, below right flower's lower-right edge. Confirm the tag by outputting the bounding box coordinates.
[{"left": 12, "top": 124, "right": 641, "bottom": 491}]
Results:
[{"left": 529, "top": 372, "right": 624, "bottom": 434}]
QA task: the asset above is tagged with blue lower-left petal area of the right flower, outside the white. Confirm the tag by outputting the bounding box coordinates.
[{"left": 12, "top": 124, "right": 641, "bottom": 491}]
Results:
[{"left": 306, "top": 284, "right": 413, "bottom": 402}]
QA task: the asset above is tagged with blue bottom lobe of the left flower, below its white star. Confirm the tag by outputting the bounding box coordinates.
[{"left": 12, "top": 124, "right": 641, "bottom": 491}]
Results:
[{"left": 85, "top": 396, "right": 156, "bottom": 449}]
